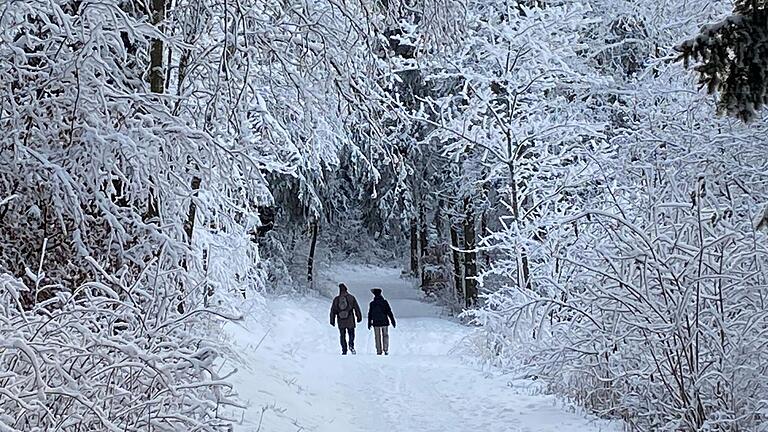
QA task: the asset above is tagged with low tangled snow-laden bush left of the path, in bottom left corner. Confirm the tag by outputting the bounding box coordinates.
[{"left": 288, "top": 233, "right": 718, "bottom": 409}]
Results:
[{"left": 0, "top": 273, "right": 240, "bottom": 432}]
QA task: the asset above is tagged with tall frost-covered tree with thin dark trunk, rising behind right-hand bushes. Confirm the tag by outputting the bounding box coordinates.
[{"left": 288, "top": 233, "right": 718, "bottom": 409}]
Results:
[{"left": 416, "top": 2, "right": 603, "bottom": 306}]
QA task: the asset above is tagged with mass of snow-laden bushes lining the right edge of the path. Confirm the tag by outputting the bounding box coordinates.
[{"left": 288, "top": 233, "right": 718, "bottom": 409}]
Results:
[{"left": 470, "top": 148, "right": 768, "bottom": 431}]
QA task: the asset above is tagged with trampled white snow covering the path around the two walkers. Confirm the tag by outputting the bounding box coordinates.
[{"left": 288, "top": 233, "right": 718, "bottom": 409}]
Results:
[{"left": 222, "top": 265, "right": 621, "bottom": 432}]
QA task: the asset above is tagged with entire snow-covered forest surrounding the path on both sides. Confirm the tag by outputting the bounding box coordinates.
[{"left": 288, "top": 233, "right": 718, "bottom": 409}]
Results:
[{"left": 0, "top": 0, "right": 768, "bottom": 431}]
